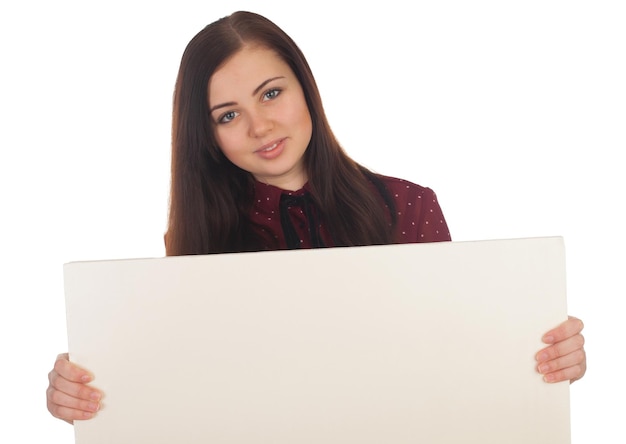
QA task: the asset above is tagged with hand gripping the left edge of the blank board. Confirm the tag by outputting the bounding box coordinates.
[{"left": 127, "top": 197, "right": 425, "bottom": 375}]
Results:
[{"left": 46, "top": 353, "right": 102, "bottom": 424}]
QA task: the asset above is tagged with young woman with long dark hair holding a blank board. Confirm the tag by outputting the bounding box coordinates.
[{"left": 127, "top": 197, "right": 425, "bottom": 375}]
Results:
[{"left": 47, "top": 12, "right": 586, "bottom": 422}]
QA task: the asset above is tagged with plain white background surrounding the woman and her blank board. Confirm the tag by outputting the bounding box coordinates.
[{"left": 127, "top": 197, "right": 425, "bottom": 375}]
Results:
[{"left": 0, "top": 0, "right": 626, "bottom": 444}]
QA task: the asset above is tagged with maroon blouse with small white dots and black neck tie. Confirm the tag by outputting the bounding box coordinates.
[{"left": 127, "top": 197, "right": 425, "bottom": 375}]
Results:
[{"left": 250, "top": 176, "right": 450, "bottom": 250}]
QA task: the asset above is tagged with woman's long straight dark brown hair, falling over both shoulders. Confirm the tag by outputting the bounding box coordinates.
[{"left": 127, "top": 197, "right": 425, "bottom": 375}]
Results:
[{"left": 165, "top": 11, "right": 395, "bottom": 256}]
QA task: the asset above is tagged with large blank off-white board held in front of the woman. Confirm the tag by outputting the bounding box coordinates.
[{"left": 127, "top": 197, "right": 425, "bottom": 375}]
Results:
[{"left": 64, "top": 237, "right": 570, "bottom": 444}]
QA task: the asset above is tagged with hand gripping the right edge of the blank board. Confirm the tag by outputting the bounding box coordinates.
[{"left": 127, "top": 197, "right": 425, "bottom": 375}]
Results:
[{"left": 535, "top": 316, "right": 587, "bottom": 383}]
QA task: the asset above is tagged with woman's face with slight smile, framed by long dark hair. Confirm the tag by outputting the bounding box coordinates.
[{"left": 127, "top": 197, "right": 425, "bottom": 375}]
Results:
[{"left": 208, "top": 46, "right": 312, "bottom": 190}]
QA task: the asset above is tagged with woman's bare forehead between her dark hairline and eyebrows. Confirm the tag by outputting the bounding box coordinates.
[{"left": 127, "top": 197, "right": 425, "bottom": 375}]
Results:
[{"left": 208, "top": 46, "right": 295, "bottom": 102}]
